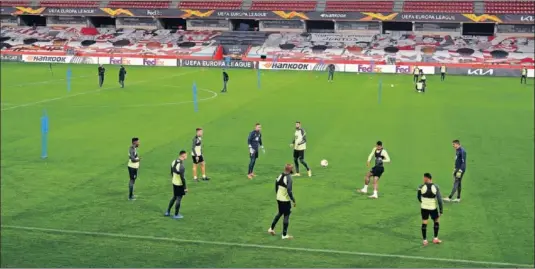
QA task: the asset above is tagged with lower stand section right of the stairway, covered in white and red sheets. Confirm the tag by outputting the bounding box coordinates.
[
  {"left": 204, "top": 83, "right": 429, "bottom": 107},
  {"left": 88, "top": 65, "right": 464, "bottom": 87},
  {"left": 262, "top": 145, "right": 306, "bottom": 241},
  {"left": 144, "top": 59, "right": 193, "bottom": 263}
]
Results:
[{"left": 248, "top": 33, "right": 535, "bottom": 64}]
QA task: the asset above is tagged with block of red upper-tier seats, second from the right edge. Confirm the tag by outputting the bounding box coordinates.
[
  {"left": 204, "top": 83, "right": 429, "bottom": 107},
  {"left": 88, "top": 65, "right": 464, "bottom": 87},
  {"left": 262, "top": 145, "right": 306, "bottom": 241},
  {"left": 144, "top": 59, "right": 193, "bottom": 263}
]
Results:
[{"left": 403, "top": 1, "right": 474, "bottom": 13}]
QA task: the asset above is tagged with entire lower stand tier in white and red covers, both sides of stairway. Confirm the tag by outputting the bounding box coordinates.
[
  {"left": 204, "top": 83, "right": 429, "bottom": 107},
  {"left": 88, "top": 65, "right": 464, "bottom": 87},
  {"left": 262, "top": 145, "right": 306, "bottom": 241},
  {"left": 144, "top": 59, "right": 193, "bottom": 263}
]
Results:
[{"left": 1, "top": 26, "right": 535, "bottom": 64}]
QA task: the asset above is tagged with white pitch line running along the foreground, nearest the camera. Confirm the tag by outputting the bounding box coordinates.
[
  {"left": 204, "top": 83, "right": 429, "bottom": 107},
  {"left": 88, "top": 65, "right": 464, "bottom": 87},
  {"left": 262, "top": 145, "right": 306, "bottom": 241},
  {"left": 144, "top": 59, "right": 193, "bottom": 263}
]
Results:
[{"left": 1, "top": 225, "right": 533, "bottom": 268}]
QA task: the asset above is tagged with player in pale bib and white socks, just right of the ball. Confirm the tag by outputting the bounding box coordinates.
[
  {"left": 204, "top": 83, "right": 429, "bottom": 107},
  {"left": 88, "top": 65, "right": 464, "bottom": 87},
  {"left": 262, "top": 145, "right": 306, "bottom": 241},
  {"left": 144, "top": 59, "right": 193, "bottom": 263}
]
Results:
[{"left": 357, "top": 141, "right": 390, "bottom": 199}]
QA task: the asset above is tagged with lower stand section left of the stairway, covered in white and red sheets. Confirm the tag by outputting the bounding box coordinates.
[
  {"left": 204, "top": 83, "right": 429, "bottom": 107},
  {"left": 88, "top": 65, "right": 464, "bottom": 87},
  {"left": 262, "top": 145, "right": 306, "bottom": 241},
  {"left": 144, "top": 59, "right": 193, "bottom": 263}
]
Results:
[{"left": 1, "top": 26, "right": 221, "bottom": 57}]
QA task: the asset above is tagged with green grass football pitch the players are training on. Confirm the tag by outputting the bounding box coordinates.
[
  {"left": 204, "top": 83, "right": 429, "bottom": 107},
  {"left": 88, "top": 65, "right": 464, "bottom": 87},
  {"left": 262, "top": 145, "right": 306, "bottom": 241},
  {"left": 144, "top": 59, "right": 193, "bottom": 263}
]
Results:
[{"left": 1, "top": 63, "right": 534, "bottom": 267}]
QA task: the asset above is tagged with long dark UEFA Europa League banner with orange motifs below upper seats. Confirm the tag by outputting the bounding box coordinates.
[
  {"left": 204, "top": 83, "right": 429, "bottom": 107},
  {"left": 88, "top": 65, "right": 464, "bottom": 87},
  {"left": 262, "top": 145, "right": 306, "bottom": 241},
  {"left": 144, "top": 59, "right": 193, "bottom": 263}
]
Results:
[{"left": 0, "top": 6, "right": 535, "bottom": 24}]
